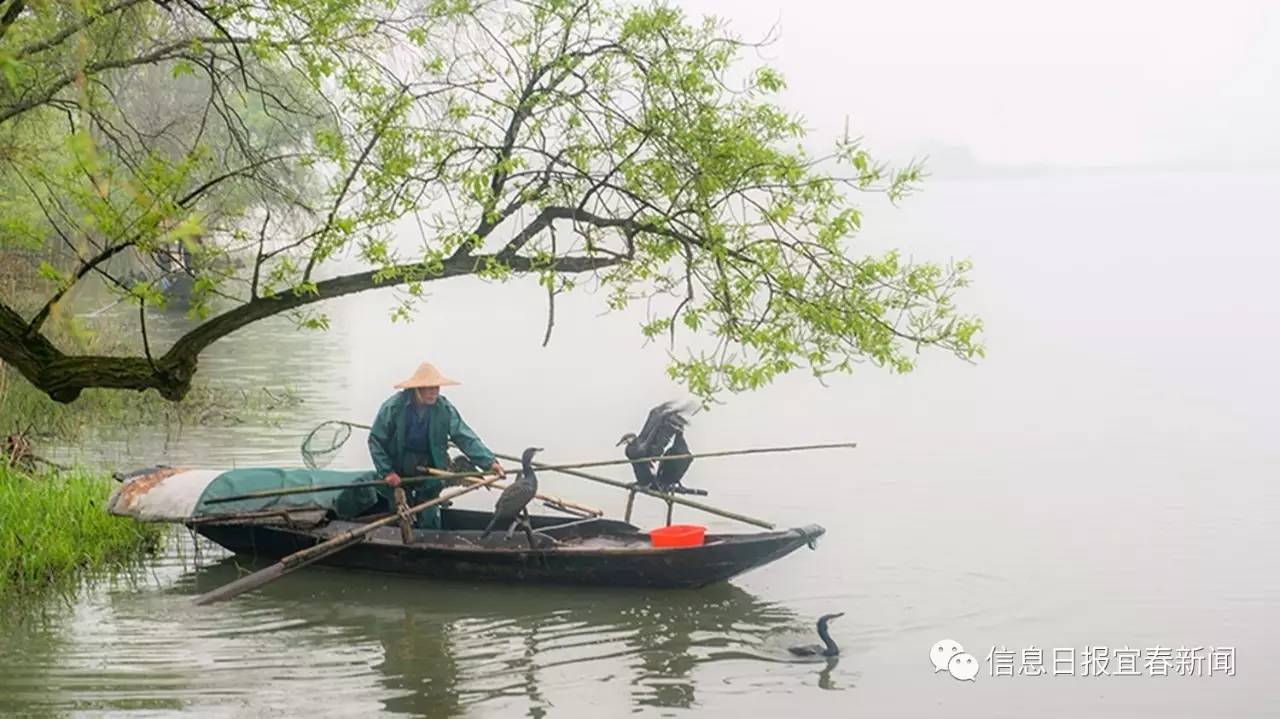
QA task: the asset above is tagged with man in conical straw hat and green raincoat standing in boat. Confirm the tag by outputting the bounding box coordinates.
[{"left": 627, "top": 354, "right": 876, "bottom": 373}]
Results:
[{"left": 369, "top": 362, "right": 507, "bottom": 528}]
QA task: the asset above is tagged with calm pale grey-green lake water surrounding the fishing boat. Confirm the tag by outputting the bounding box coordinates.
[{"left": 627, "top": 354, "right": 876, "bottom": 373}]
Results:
[{"left": 0, "top": 167, "right": 1280, "bottom": 716}]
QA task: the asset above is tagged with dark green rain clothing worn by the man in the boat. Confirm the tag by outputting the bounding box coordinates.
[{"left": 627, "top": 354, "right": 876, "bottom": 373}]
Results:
[{"left": 351, "top": 390, "right": 494, "bottom": 528}]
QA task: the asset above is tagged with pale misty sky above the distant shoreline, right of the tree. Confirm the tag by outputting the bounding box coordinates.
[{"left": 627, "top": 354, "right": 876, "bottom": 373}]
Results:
[{"left": 677, "top": 0, "right": 1280, "bottom": 165}]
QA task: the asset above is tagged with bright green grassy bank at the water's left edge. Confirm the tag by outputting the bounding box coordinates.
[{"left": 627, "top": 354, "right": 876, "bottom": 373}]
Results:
[{"left": 0, "top": 462, "right": 163, "bottom": 596}]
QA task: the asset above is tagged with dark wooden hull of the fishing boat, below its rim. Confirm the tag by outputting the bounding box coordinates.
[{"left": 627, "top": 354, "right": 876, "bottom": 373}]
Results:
[{"left": 196, "top": 509, "right": 824, "bottom": 589}]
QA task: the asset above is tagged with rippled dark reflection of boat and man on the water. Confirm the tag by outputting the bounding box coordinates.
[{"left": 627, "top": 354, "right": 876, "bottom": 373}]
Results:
[{"left": 175, "top": 550, "right": 798, "bottom": 716}]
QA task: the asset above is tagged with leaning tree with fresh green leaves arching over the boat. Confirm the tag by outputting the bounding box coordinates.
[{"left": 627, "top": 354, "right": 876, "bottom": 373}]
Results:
[{"left": 0, "top": 0, "right": 982, "bottom": 402}]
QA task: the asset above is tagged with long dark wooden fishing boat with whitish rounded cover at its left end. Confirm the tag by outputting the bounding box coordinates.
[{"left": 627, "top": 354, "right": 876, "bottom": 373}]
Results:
[{"left": 109, "top": 468, "right": 826, "bottom": 587}]
